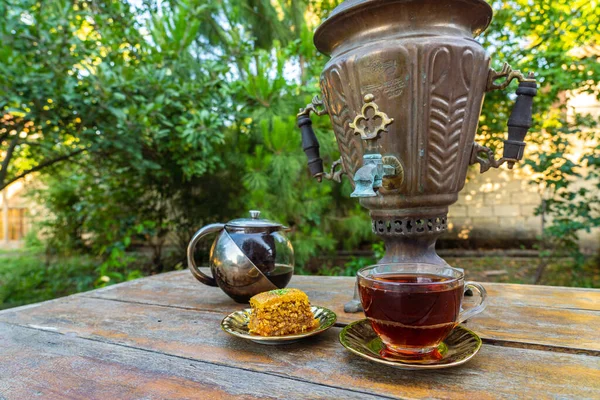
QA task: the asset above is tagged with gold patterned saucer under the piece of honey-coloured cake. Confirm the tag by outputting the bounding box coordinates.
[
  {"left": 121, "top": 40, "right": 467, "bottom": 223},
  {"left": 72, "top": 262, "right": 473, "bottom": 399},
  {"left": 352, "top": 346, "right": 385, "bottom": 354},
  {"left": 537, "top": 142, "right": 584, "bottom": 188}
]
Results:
[{"left": 221, "top": 306, "right": 337, "bottom": 344}]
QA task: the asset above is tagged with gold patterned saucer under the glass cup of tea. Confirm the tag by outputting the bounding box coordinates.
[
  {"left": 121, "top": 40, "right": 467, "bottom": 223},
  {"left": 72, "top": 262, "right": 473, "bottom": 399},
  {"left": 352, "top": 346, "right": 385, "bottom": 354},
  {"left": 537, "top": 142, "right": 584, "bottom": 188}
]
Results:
[{"left": 340, "top": 319, "right": 481, "bottom": 370}]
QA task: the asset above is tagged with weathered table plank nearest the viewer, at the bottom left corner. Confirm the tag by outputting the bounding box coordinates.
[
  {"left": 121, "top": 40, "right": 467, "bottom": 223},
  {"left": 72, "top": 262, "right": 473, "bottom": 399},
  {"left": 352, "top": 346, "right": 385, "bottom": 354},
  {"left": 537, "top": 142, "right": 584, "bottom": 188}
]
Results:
[{"left": 0, "top": 324, "right": 384, "bottom": 400}]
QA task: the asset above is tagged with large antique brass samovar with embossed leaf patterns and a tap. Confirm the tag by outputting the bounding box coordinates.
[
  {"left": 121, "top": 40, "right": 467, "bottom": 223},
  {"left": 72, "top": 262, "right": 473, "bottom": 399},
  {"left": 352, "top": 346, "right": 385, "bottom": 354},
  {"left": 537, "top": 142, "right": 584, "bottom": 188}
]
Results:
[{"left": 298, "top": 0, "right": 537, "bottom": 312}]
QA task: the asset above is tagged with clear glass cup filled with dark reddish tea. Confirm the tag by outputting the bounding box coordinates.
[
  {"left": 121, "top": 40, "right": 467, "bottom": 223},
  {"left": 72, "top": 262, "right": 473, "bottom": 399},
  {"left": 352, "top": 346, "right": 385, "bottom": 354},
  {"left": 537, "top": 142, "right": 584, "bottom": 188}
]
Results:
[{"left": 357, "top": 263, "right": 487, "bottom": 358}]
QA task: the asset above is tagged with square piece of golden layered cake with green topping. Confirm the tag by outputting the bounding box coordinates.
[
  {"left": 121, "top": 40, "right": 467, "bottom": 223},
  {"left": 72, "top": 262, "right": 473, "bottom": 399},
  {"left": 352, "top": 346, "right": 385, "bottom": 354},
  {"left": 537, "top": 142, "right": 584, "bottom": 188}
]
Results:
[{"left": 248, "top": 289, "right": 319, "bottom": 336}]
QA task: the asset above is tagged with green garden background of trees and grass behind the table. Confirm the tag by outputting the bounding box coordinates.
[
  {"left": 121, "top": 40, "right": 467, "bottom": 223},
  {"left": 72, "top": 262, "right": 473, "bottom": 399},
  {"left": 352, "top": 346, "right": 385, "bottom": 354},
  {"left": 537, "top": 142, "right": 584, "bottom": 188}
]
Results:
[{"left": 0, "top": 0, "right": 600, "bottom": 309}]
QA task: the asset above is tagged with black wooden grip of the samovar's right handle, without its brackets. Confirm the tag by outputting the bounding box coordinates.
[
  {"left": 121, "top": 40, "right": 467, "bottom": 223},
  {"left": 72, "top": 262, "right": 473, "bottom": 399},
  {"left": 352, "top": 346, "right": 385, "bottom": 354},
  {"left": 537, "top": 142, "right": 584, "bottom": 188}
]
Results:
[{"left": 504, "top": 82, "right": 537, "bottom": 160}]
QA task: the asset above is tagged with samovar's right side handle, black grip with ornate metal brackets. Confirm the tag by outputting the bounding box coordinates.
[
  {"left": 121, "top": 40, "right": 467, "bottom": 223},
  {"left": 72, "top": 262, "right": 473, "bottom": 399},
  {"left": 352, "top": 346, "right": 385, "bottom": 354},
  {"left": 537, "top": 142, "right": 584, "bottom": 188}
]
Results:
[{"left": 470, "top": 63, "right": 537, "bottom": 173}]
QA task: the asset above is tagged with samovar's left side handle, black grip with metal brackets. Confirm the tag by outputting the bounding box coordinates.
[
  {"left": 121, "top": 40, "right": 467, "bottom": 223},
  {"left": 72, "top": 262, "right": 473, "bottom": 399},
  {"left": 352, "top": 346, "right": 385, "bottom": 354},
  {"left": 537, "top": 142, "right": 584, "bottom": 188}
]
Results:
[{"left": 296, "top": 96, "right": 344, "bottom": 183}]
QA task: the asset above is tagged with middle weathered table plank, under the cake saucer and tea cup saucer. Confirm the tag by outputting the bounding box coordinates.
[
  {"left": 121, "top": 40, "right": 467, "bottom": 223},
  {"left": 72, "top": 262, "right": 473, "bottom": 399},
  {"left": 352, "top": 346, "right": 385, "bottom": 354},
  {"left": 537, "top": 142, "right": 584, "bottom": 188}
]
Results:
[{"left": 0, "top": 297, "right": 600, "bottom": 399}]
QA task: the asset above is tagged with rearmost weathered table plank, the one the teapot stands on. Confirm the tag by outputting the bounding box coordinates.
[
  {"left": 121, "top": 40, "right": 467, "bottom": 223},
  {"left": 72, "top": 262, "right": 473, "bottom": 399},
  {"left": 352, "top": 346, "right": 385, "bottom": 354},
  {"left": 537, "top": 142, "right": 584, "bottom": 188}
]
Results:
[{"left": 78, "top": 271, "right": 600, "bottom": 351}]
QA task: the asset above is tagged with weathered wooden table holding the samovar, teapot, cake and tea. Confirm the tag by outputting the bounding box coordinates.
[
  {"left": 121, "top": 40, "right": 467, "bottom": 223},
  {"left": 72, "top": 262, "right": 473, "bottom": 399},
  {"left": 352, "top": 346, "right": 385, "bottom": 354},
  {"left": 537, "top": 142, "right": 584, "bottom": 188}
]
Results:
[{"left": 0, "top": 271, "right": 600, "bottom": 400}]
